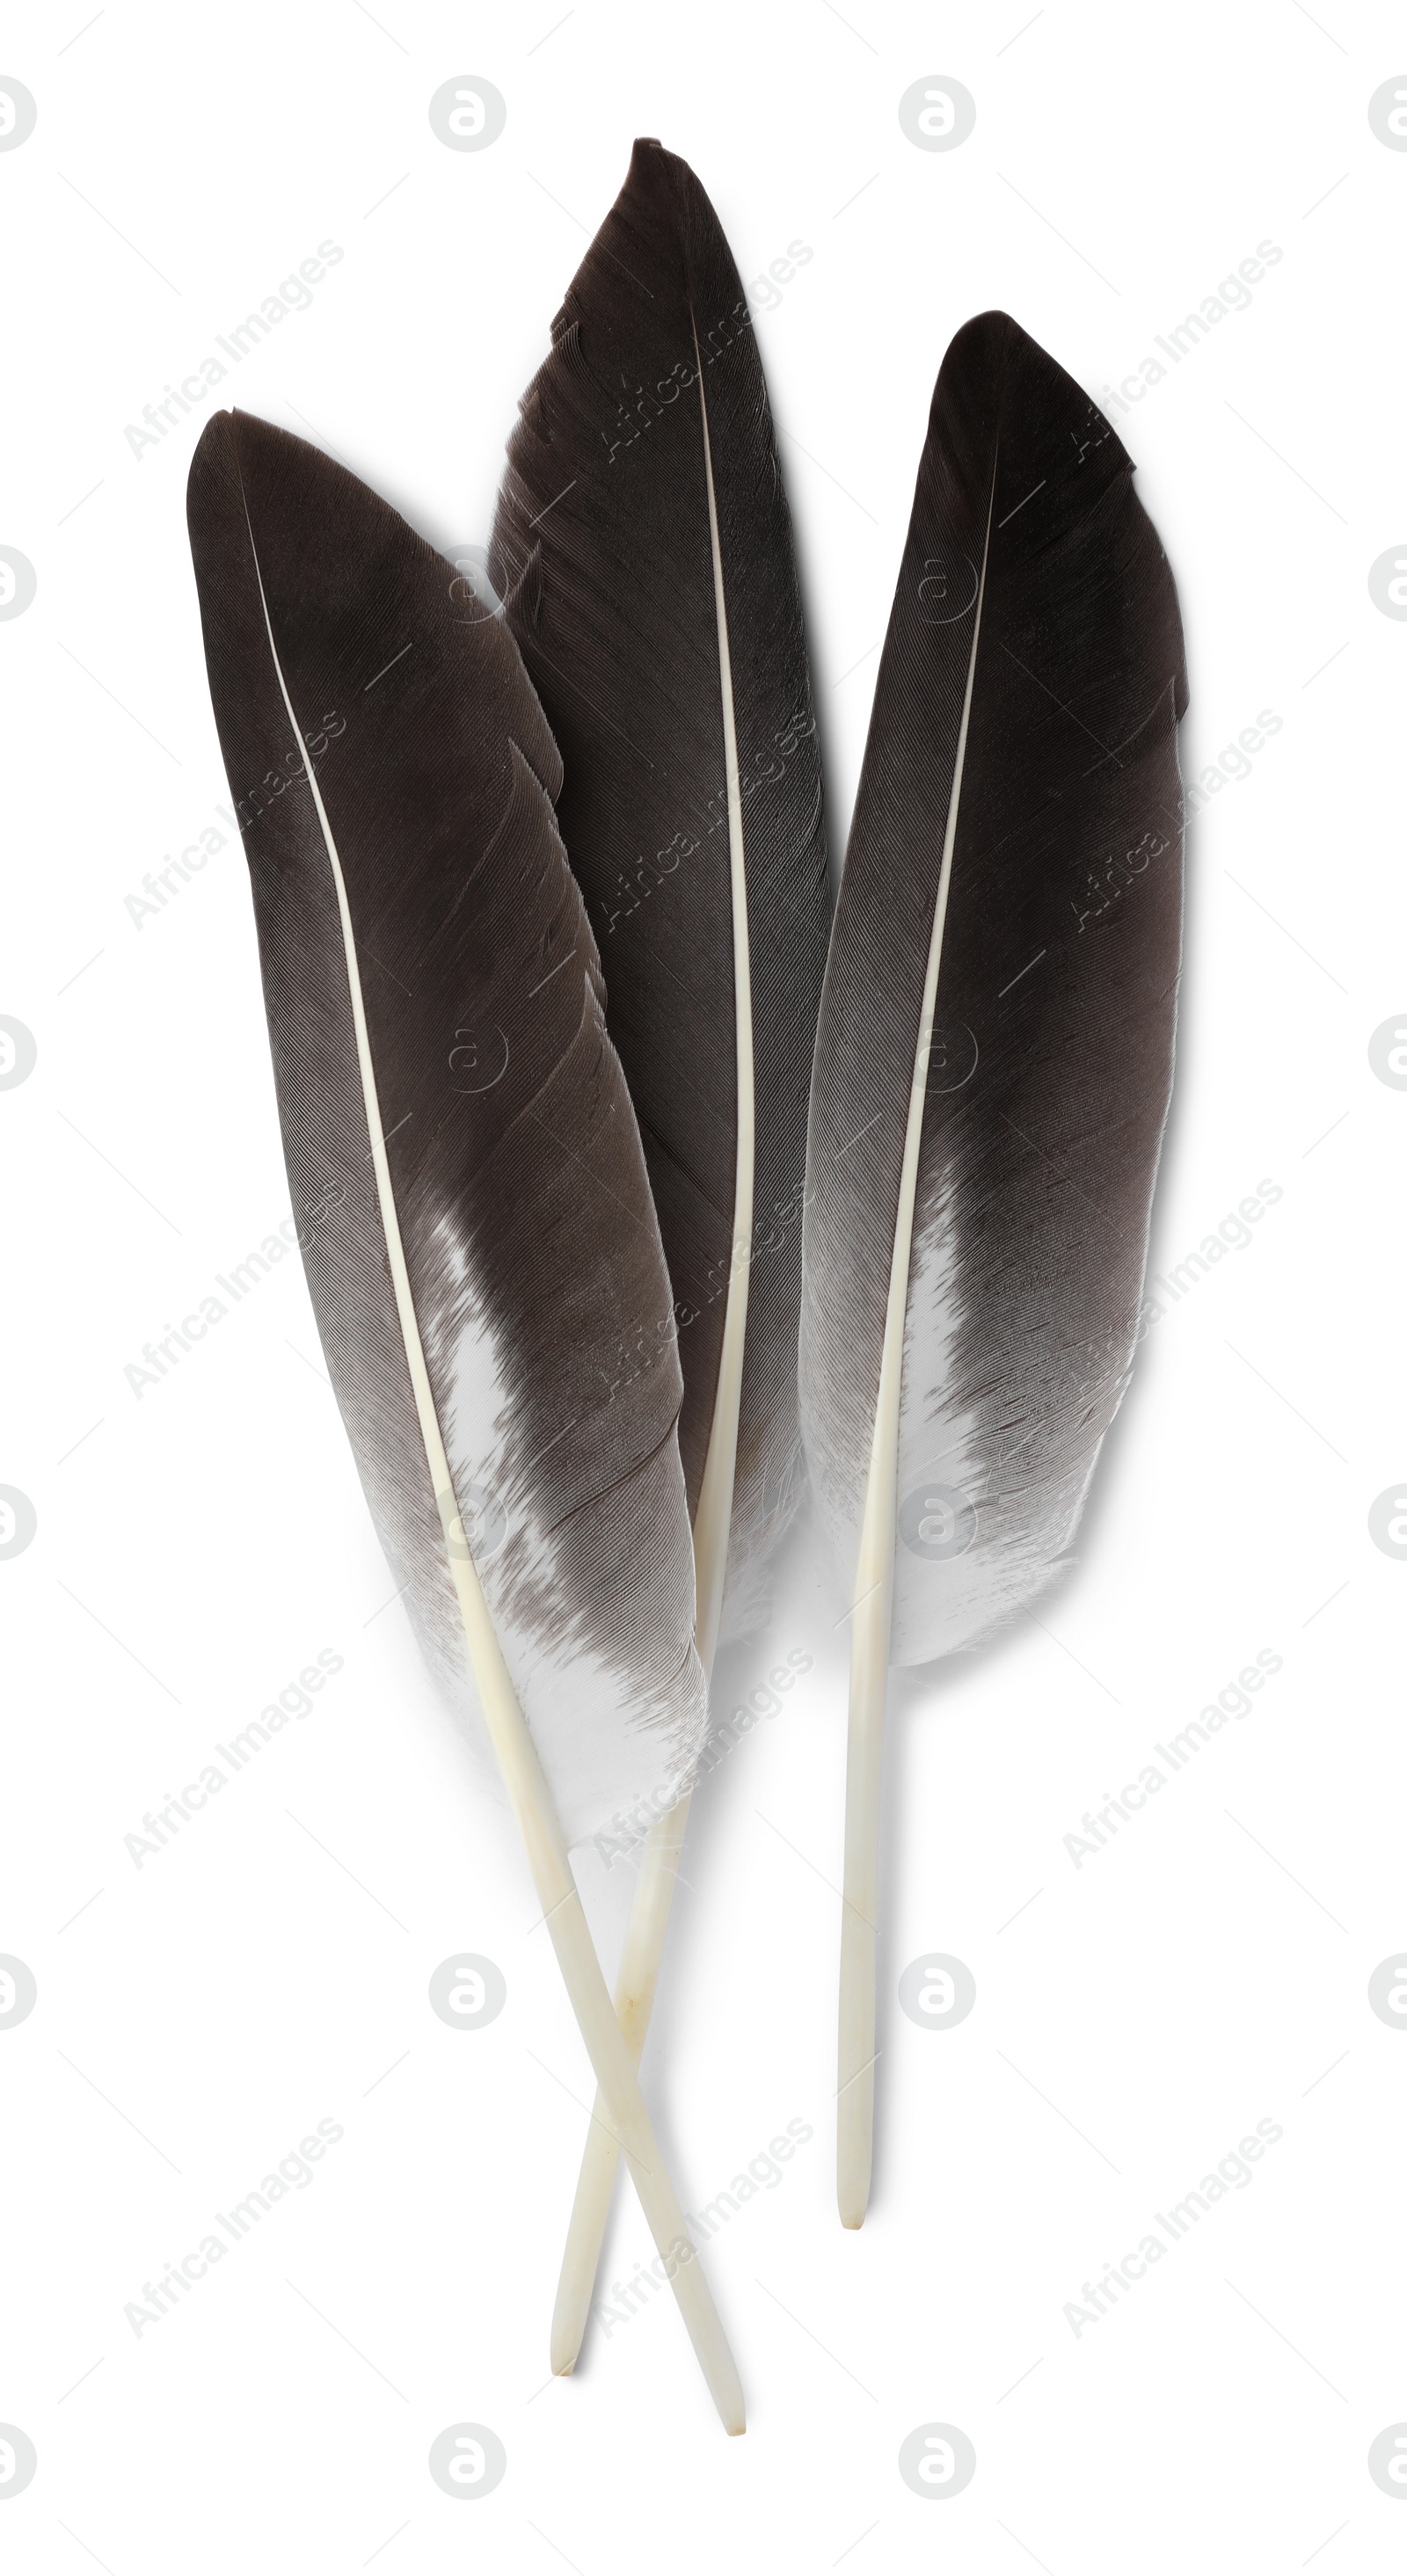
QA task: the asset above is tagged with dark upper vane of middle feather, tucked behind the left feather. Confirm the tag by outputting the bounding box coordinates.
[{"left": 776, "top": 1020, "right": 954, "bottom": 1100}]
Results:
[{"left": 490, "top": 142, "right": 830, "bottom": 1656}]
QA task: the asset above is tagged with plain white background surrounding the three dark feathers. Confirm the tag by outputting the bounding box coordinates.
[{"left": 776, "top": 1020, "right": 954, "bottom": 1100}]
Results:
[{"left": 0, "top": 0, "right": 1407, "bottom": 2576}]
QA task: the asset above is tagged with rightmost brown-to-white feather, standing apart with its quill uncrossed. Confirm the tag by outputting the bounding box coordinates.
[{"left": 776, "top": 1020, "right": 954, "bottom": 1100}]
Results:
[{"left": 801, "top": 314, "right": 1185, "bottom": 2226}]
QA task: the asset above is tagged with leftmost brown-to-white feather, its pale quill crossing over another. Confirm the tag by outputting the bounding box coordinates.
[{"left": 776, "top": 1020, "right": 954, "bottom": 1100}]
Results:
[{"left": 188, "top": 415, "right": 742, "bottom": 2432}]
